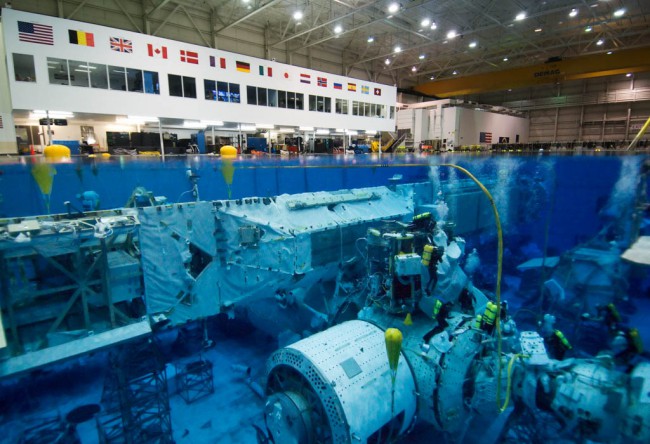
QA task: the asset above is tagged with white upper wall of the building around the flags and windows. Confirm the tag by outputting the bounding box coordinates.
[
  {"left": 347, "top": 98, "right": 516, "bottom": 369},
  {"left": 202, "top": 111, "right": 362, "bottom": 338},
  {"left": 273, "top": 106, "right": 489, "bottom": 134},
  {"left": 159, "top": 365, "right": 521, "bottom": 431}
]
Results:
[{"left": 3, "top": 9, "right": 396, "bottom": 131}]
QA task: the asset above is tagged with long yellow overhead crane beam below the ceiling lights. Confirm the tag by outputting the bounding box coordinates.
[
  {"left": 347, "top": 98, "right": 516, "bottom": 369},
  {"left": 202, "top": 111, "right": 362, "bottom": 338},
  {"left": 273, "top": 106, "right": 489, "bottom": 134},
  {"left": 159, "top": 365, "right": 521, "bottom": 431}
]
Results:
[{"left": 413, "top": 46, "right": 650, "bottom": 98}]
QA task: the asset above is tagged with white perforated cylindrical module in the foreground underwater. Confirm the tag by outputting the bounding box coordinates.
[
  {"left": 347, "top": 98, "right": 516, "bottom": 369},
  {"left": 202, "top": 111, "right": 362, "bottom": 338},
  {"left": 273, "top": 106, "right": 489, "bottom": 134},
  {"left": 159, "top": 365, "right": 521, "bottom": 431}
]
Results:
[{"left": 266, "top": 320, "right": 417, "bottom": 444}]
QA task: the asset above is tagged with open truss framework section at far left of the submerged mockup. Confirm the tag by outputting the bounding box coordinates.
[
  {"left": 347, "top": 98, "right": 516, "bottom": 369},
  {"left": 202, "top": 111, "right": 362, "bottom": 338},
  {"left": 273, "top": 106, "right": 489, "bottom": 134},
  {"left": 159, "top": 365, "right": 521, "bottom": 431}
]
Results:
[{"left": 0, "top": 210, "right": 141, "bottom": 355}]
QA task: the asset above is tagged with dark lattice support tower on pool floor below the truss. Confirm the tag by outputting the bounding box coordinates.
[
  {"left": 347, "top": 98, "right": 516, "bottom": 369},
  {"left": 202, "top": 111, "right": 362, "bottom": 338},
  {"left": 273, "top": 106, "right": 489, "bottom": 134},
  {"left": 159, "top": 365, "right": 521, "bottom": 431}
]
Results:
[{"left": 97, "top": 338, "right": 174, "bottom": 444}]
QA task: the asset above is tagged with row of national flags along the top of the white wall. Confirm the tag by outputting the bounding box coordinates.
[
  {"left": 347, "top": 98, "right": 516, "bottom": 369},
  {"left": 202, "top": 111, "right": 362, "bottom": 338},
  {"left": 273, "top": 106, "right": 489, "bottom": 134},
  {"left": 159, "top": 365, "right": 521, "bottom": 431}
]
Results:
[{"left": 18, "top": 21, "right": 381, "bottom": 96}]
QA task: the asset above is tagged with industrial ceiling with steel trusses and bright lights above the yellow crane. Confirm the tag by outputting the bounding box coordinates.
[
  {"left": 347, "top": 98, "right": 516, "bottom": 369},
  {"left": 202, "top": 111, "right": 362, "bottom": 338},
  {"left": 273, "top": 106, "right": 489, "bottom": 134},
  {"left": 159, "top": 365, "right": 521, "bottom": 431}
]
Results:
[{"left": 7, "top": 0, "right": 650, "bottom": 93}]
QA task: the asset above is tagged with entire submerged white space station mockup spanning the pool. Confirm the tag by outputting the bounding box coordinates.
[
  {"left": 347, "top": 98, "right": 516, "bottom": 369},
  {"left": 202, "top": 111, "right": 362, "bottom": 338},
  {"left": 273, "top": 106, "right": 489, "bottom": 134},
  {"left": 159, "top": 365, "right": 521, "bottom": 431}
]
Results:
[{"left": 0, "top": 164, "right": 650, "bottom": 444}]
